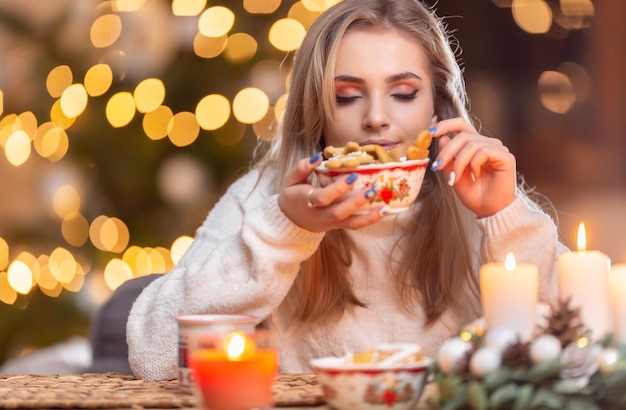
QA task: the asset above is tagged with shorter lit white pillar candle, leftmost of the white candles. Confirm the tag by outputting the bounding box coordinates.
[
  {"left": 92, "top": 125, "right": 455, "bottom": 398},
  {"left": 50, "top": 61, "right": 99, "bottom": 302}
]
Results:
[{"left": 480, "top": 253, "right": 539, "bottom": 340}]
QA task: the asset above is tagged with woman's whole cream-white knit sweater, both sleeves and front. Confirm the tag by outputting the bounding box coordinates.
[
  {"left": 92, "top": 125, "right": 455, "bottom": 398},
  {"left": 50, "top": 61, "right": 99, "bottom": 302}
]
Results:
[{"left": 127, "top": 166, "right": 566, "bottom": 380}]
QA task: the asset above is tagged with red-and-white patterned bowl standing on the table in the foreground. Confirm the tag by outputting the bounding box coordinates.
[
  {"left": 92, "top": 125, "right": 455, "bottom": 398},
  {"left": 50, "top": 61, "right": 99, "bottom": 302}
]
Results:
[{"left": 310, "top": 344, "right": 431, "bottom": 410}]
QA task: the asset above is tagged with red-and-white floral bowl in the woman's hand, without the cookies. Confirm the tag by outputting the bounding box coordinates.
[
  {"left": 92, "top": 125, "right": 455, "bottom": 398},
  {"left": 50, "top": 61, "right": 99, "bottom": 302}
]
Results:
[{"left": 315, "top": 158, "right": 429, "bottom": 214}]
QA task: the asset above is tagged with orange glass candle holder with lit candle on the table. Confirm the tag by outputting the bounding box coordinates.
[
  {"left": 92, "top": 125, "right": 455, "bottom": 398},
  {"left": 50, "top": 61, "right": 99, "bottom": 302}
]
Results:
[{"left": 189, "top": 330, "right": 278, "bottom": 410}]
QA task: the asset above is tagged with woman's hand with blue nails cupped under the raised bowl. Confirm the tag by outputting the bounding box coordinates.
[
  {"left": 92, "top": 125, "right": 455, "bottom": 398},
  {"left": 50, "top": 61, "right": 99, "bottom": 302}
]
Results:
[{"left": 278, "top": 153, "right": 387, "bottom": 232}]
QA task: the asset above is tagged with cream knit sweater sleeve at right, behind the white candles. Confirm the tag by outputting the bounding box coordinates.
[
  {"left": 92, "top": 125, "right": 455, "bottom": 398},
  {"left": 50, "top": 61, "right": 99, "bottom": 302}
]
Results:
[{"left": 478, "top": 194, "right": 568, "bottom": 303}]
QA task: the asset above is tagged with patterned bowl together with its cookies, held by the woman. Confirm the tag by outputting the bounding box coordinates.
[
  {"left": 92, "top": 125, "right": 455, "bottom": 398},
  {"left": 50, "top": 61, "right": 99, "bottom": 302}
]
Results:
[{"left": 315, "top": 131, "right": 432, "bottom": 214}]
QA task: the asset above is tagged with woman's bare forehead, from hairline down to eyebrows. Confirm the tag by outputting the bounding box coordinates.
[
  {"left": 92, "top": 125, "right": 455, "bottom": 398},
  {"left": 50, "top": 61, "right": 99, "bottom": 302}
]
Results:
[{"left": 335, "top": 27, "right": 430, "bottom": 75}]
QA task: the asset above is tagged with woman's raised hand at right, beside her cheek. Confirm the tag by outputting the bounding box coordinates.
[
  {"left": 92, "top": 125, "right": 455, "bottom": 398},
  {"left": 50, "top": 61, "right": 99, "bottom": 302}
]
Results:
[{"left": 433, "top": 118, "right": 517, "bottom": 218}]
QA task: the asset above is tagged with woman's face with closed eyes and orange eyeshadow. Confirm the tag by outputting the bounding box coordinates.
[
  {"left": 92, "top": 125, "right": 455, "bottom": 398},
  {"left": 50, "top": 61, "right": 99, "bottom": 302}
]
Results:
[{"left": 324, "top": 28, "right": 436, "bottom": 156}]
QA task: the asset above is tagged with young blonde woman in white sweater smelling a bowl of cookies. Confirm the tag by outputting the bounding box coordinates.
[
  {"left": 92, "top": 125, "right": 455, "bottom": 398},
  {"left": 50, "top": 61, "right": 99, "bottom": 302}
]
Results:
[{"left": 127, "top": 0, "right": 566, "bottom": 380}]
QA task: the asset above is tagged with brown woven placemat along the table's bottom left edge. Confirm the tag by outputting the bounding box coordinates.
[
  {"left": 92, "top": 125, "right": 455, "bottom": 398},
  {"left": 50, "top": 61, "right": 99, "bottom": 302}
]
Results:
[{"left": 0, "top": 373, "right": 324, "bottom": 409}]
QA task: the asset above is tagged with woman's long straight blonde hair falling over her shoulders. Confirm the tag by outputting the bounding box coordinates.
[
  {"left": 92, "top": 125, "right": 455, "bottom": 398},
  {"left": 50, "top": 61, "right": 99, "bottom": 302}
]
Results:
[{"left": 254, "top": 0, "right": 478, "bottom": 324}]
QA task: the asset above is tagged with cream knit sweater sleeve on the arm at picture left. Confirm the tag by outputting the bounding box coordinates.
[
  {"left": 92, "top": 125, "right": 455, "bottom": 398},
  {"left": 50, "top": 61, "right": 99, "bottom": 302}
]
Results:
[{"left": 127, "top": 170, "right": 323, "bottom": 380}]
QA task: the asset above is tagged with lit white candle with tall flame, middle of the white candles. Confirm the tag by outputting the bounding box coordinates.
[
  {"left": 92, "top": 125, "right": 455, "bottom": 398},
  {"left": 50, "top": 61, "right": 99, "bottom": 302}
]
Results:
[{"left": 557, "top": 223, "right": 612, "bottom": 340}]
